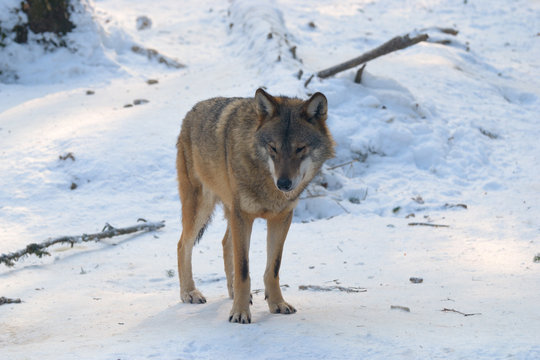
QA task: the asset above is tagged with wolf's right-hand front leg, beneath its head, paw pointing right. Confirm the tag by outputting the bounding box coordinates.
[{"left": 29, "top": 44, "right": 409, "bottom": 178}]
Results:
[{"left": 264, "top": 211, "right": 296, "bottom": 314}]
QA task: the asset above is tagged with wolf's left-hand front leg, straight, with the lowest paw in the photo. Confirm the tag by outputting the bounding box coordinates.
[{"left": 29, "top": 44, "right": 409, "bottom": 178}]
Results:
[{"left": 229, "top": 208, "right": 253, "bottom": 324}]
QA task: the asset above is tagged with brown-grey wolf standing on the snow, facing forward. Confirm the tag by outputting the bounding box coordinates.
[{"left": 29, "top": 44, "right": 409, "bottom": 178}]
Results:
[{"left": 176, "top": 89, "right": 335, "bottom": 324}]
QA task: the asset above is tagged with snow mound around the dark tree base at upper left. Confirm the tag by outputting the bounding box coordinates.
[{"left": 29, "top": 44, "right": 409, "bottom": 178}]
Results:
[{"left": 0, "top": 0, "right": 183, "bottom": 85}]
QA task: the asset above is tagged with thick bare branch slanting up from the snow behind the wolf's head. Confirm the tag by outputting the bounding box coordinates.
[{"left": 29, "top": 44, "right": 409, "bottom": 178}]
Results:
[{"left": 317, "top": 34, "right": 429, "bottom": 79}]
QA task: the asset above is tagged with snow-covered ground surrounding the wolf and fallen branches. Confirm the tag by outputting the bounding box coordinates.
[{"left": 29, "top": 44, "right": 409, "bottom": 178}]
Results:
[{"left": 0, "top": 0, "right": 540, "bottom": 359}]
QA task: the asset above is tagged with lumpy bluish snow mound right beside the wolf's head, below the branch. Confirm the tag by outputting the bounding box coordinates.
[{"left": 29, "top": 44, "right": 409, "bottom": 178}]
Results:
[{"left": 296, "top": 63, "right": 497, "bottom": 221}]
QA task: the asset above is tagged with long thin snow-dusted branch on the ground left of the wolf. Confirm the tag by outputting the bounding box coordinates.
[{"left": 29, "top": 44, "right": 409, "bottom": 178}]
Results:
[{"left": 0, "top": 219, "right": 165, "bottom": 266}]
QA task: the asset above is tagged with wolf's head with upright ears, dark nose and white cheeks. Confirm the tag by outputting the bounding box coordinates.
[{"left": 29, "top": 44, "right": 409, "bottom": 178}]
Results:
[{"left": 255, "top": 89, "right": 334, "bottom": 194}]
